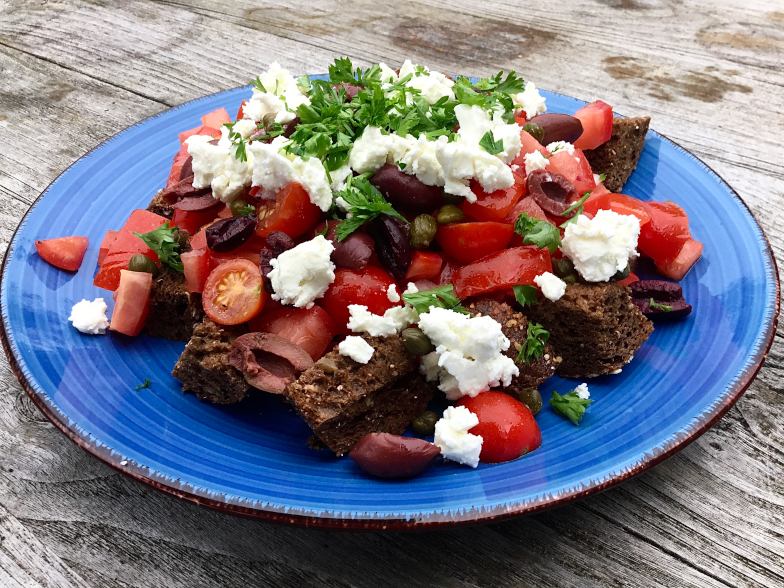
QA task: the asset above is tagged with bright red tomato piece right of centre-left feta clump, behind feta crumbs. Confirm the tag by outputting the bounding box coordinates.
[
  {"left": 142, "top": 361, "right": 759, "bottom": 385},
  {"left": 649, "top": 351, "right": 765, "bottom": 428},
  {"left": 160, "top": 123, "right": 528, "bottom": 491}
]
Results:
[{"left": 319, "top": 265, "right": 396, "bottom": 335}]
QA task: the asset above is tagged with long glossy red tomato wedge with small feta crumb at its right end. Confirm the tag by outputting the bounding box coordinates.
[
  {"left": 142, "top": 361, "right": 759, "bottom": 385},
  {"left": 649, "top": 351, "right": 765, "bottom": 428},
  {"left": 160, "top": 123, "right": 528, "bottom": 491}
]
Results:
[{"left": 452, "top": 245, "right": 553, "bottom": 299}]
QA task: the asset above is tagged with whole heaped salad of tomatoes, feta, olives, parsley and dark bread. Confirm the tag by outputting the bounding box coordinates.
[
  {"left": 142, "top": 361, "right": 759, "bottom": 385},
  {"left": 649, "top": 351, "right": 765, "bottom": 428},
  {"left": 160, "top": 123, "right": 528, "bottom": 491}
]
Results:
[{"left": 36, "top": 58, "right": 702, "bottom": 477}]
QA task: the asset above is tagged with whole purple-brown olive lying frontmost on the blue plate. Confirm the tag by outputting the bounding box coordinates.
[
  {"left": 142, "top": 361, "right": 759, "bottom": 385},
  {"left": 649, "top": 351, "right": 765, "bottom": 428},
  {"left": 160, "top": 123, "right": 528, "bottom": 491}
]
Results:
[{"left": 348, "top": 433, "right": 441, "bottom": 478}]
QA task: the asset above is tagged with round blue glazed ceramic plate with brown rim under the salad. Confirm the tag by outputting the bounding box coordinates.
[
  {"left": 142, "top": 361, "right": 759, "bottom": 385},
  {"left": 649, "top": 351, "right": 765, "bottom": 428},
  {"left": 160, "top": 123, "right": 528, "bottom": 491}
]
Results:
[{"left": 0, "top": 81, "right": 778, "bottom": 528}]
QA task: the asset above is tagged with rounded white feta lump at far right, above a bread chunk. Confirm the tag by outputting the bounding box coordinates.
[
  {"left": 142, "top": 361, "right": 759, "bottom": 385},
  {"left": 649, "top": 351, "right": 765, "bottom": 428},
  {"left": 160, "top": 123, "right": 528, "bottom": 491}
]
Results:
[{"left": 561, "top": 210, "right": 640, "bottom": 282}]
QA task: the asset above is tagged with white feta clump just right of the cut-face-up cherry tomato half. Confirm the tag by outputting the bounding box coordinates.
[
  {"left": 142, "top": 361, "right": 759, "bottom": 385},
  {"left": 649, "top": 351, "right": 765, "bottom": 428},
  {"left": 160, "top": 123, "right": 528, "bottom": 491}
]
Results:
[{"left": 269, "top": 235, "right": 335, "bottom": 308}]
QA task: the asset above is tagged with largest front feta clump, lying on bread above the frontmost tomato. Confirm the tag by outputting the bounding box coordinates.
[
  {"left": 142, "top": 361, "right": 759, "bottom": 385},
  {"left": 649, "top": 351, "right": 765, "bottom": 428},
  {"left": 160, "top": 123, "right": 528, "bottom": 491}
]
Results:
[{"left": 419, "top": 308, "right": 520, "bottom": 400}]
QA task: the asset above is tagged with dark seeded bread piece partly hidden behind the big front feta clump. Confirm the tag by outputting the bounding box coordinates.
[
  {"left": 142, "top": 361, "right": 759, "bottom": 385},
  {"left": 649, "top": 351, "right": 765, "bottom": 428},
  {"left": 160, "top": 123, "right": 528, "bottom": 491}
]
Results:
[{"left": 468, "top": 299, "right": 559, "bottom": 398}]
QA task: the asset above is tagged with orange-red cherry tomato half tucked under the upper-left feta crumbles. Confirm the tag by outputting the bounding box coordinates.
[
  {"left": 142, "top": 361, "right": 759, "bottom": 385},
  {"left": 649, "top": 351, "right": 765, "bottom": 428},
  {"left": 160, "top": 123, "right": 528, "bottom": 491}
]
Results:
[{"left": 256, "top": 183, "right": 321, "bottom": 239}]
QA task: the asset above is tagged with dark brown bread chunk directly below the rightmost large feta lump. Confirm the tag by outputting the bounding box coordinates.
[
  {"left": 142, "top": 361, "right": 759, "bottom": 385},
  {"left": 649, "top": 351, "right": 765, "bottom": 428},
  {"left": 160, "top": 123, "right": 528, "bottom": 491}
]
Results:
[{"left": 526, "top": 282, "right": 653, "bottom": 378}]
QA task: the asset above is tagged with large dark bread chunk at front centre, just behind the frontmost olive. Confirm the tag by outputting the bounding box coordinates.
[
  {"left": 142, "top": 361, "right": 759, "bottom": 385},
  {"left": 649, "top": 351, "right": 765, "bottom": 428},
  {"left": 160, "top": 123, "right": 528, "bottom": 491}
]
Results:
[{"left": 286, "top": 335, "right": 433, "bottom": 455}]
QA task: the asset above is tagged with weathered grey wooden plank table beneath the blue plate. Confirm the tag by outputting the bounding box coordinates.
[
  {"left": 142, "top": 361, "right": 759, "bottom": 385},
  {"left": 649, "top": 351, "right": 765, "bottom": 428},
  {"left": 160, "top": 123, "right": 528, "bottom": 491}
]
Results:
[{"left": 0, "top": 0, "right": 784, "bottom": 588}]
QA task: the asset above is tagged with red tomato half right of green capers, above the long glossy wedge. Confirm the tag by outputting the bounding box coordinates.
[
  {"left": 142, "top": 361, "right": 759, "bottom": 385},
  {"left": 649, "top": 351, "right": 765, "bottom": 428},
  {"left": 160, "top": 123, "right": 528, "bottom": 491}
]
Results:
[{"left": 436, "top": 223, "right": 514, "bottom": 263}]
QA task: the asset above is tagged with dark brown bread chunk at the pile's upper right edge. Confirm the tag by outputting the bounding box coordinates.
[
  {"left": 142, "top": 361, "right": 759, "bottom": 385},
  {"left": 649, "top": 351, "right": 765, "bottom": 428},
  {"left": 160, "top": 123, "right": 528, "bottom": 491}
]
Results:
[{"left": 585, "top": 116, "right": 651, "bottom": 192}]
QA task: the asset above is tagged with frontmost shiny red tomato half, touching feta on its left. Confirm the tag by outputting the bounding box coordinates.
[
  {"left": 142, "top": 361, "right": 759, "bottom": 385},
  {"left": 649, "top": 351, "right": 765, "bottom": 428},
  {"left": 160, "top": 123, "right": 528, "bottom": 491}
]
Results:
[{"left": 457, "top": 391, "right": 542, "bottom": 463}]
